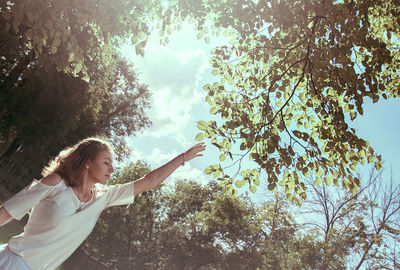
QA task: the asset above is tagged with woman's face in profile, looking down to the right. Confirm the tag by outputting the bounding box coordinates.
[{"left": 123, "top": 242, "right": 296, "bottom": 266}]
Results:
[{"left": 87, "top": 150, "right": 114, "bottom": 185}]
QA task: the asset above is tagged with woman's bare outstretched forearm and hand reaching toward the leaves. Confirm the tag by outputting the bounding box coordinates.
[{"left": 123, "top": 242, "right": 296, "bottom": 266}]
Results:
[{"left": 134, "top": 143, "right": 206, "bottom": 195}]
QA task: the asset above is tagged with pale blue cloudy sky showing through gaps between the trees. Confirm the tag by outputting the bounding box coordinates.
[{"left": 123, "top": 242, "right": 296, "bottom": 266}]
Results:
[{"left": 122, "top": 24, "right": 400, "bottom": 192}]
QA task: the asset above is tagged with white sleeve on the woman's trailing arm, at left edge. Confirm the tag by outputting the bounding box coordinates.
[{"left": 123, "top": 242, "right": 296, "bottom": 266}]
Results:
[{"left": 3, "top": 180, "right": 57, "bottom": 220}]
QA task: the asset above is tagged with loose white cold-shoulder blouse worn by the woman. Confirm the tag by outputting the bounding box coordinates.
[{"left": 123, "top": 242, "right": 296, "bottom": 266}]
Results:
[{"left": 3, "top": 180, "right": 134, "bottom": 270}]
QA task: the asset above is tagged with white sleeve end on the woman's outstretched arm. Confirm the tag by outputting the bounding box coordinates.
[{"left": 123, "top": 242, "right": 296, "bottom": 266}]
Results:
[{"left": 106, "top": 182, "right": 135, "bottom": 207}]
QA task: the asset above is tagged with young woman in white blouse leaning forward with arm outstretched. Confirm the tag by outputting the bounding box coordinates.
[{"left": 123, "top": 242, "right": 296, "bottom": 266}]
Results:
[{"left": 0, "top": 138, "right": 205, "bottom": 270}]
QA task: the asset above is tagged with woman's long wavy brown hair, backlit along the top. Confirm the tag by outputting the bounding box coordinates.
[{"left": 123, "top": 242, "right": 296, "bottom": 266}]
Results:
[{"left": 42, "top": 137, "right": 112, "bottom": 186}]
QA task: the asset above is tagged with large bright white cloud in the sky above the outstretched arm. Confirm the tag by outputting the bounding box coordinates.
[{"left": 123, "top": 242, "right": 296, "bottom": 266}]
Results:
[{"left": 123, "top": 37, "right": 209, "bottom": 142}]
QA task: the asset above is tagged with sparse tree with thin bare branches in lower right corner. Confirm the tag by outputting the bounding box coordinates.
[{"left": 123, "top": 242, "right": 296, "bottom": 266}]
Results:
[{"left": 301, "top": 170, "right": 400, "bottom": 269}]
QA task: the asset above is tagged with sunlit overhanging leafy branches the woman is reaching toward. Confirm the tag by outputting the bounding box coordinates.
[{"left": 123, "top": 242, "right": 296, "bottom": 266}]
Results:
[{"left": 178, "top": 0, "right": 400, "bottom": 204}]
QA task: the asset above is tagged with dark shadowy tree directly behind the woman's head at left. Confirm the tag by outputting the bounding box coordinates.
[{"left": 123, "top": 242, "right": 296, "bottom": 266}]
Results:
[{"left": 0, "top": 59, "right": 150, "bottom": 192}]
